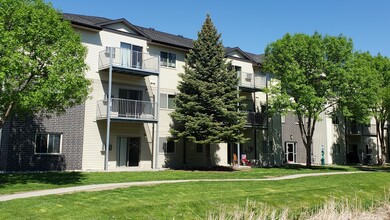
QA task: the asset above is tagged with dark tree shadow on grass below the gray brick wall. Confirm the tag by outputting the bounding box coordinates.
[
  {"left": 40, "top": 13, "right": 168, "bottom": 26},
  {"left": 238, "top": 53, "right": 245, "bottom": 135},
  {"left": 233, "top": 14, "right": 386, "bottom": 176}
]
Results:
[{"left": 0, "top": 172, "right": 85, "bottom": 188}]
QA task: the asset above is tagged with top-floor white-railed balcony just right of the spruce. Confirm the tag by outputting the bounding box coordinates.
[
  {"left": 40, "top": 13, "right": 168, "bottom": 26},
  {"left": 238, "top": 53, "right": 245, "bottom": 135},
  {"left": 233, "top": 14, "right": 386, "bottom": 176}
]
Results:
[{"left": 238, "top": 71, "right": 267, "bottom": 92}]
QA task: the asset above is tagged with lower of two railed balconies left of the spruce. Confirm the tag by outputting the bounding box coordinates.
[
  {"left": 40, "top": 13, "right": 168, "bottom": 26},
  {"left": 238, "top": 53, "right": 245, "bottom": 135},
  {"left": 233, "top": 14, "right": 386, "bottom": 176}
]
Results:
[{"left": 96, "top": 98, "right": 157, "bottom": 123}]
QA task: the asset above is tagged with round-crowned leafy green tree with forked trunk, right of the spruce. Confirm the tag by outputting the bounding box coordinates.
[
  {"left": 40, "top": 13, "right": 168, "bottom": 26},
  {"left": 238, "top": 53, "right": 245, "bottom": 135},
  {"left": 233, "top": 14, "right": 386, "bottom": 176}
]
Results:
[{"left": 264, "top": 32, "right": 353, "bottom": 166}]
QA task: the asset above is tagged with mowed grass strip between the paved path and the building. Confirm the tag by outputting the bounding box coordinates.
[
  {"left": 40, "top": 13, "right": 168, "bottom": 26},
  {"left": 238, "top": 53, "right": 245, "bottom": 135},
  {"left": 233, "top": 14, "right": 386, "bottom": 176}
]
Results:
[{"left": 0, "top": 166, "right": 357, "bottom": 195}]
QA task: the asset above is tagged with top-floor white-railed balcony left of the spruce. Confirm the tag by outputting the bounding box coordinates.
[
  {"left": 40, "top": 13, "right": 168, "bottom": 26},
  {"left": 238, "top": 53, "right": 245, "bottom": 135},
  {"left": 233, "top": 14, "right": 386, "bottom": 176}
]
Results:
[{"left": 99, "top": 47, "right": 160, "bottom": 76}]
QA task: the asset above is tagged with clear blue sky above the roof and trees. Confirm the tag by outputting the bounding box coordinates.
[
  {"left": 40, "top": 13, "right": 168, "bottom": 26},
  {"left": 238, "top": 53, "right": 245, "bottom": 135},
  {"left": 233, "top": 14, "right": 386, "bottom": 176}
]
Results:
[{"left": 46, "top": 0, "right": 390, "bottom": 56}]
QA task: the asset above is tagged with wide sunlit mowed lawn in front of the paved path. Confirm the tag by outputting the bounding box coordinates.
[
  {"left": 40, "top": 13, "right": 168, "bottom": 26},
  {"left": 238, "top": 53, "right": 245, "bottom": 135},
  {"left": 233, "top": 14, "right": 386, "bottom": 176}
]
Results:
[{"left": 0, "top": 172, "right": 390, "bottom": 219}]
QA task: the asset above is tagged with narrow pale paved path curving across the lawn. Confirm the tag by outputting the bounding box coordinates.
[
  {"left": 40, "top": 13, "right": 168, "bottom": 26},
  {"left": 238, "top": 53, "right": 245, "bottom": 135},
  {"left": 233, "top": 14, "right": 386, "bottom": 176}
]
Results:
[{"left": 0, "top": 171, "right": 365, "bottom": 202}]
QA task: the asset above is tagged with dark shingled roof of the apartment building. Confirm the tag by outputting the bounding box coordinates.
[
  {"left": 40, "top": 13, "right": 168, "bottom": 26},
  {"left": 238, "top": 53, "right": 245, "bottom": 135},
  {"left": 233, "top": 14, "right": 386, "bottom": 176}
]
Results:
[{"left": 63, "top": 13, "right": 264, "bottom": 63}]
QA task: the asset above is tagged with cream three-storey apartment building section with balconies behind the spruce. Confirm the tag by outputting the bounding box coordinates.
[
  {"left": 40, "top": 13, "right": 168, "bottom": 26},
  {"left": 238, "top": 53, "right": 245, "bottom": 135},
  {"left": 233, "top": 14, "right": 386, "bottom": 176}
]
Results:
[{"left": 0, "top": 14, "right": 283, "bottom": 171}]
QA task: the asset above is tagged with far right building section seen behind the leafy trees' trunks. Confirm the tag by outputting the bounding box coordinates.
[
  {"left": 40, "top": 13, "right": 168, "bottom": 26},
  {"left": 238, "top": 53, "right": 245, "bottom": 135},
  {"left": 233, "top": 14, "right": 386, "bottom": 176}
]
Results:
[{"left": 281, "top": 113, "right": 380, "bottom": 165}]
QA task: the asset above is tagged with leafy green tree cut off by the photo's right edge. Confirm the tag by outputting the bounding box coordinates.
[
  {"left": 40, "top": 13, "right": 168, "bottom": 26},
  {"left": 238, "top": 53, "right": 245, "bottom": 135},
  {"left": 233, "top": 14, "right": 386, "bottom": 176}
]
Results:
[{"left": 340, "top": 52, "right": 390, "bottom": 164}]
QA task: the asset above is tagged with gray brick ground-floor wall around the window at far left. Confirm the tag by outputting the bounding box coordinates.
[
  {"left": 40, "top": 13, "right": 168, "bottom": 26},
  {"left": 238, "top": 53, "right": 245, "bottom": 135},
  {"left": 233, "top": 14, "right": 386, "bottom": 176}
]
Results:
[{"left": 0, "top": 105, "right": 84, "bottom": 171}]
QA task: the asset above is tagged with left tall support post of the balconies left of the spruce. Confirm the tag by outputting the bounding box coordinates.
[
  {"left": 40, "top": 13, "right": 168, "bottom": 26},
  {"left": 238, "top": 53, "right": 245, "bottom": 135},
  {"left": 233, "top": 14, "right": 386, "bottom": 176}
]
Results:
[{"left": 104, "top": 47, "right": 114, "bottom": 171}]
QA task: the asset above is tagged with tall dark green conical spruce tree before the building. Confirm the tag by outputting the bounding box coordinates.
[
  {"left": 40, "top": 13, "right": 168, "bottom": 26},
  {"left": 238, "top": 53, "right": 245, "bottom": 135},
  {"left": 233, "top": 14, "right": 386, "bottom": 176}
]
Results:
[{"left": 171, "top": 16, "right": 245, "bottom": 144}]
